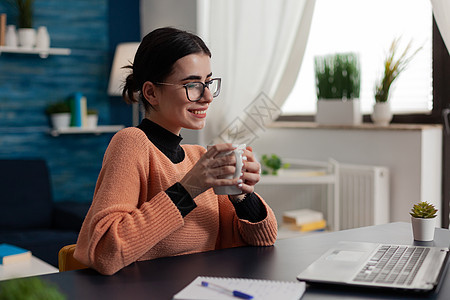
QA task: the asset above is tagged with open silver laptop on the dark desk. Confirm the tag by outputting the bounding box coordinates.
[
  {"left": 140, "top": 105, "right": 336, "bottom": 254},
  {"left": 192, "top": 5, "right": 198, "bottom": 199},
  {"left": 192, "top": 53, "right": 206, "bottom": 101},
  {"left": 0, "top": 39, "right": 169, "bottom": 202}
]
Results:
[{"left": 297, "top": 242, "right": 449, "bottom": 292}]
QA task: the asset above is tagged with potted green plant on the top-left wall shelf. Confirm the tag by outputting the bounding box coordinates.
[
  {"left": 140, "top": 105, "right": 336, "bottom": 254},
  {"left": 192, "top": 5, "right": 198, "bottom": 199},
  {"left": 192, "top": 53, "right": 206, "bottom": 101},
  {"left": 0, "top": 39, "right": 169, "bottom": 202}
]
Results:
[{"left": 6, "top": 0, "right": 36, "bottom": 48}]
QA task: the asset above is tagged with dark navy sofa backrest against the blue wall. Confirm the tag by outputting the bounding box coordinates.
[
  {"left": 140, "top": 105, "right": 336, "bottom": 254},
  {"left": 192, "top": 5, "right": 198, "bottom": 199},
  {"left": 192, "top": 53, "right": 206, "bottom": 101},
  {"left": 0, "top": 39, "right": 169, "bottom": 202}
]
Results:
[{"left": 0, "top": 159, "right": 53, "bottom": 230}]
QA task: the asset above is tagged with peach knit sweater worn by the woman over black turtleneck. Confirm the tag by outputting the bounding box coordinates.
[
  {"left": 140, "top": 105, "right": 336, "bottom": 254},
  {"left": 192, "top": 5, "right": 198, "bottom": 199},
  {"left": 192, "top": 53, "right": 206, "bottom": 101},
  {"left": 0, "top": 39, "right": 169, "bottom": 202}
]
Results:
[{"left": 74, "top": 127, "right": 277, "bottom": 274}]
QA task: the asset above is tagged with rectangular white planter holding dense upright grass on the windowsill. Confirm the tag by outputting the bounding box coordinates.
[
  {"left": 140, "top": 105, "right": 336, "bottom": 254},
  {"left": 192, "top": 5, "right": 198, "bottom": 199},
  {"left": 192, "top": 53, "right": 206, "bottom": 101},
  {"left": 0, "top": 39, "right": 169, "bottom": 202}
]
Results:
[{"left": 315, "top": 99, "right": 362, "bottom": 125}]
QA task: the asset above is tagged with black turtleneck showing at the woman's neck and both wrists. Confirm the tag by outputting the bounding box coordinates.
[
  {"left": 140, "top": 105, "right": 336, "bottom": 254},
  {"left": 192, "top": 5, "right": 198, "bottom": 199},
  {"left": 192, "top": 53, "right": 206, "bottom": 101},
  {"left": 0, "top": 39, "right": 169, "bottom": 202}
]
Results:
[{"left": 137, "top": 119, "right": 267, "bottom": 222}]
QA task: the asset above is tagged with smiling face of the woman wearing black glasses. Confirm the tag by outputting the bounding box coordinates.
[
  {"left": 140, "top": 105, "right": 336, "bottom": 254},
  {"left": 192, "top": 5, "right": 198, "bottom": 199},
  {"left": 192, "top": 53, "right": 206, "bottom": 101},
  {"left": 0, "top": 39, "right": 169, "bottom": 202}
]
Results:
[{"left": 147, "top": 53, "right": 213, "bottom": 135}]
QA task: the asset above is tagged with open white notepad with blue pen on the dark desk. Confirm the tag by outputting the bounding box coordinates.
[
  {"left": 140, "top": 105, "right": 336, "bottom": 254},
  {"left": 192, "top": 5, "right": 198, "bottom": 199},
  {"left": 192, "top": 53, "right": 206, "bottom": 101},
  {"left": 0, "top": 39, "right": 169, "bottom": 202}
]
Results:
[{"left": 173, "top": 276, "right": 305, "bottom": 300}]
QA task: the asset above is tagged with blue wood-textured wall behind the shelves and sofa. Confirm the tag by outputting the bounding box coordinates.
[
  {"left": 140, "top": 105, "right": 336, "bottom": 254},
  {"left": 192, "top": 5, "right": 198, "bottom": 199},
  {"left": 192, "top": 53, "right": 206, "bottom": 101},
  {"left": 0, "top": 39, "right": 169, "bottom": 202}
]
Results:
[{"left": 0, "top": 0, "right": 118, "bottom": 202}]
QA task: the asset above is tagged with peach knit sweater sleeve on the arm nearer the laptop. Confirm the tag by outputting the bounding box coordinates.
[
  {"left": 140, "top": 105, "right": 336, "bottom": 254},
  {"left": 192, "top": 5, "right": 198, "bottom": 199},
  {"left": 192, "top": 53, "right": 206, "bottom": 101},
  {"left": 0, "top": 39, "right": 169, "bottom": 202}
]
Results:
[{"left": 216, "top": 193, "right": 277, "bottom": 249}]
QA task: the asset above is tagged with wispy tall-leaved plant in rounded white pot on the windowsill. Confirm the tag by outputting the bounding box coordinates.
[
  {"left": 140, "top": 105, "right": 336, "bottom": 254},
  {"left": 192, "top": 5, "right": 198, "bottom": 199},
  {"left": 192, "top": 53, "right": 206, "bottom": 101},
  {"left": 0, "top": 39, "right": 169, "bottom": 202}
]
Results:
[{"left": 371, "top": 38, "right": 422, "bottom": 126}]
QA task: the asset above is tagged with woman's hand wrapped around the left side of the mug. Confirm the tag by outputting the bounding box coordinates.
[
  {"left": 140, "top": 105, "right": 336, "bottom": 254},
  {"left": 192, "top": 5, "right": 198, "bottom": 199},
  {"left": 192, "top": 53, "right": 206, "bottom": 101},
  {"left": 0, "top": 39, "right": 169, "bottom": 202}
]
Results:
[{"left": 180, "top": 143, "right": 243, "bottom": 198}]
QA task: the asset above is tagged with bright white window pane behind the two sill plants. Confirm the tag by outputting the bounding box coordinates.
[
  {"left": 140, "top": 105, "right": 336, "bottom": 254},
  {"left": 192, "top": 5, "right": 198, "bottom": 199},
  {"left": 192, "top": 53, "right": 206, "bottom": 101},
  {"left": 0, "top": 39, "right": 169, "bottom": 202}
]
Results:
[{"left": 282, "top": 0, "right": 433, "bottom": 115}]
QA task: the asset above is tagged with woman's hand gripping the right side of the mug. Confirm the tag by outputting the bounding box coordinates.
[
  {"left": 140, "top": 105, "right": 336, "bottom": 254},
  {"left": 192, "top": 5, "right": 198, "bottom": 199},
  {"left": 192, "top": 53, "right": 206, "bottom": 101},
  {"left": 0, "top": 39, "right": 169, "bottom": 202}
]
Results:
[{"left": 230, "top": 147, "right": 261, "bottom": 201}]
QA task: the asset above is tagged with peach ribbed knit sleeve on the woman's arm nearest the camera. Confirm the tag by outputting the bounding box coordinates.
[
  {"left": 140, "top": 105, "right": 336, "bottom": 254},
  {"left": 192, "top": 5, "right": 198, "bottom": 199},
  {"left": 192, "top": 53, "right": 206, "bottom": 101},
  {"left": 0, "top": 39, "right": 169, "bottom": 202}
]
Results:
[{"left": 74, "top": 129, "right": 184, "bottom": 274}]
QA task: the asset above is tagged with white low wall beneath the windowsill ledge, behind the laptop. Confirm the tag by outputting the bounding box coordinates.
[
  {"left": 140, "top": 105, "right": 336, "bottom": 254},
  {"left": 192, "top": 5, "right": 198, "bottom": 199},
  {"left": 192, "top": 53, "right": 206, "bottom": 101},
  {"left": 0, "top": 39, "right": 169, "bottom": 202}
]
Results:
[{"left": 252, "top": 126, "right": 442, "bottom": 224}]
